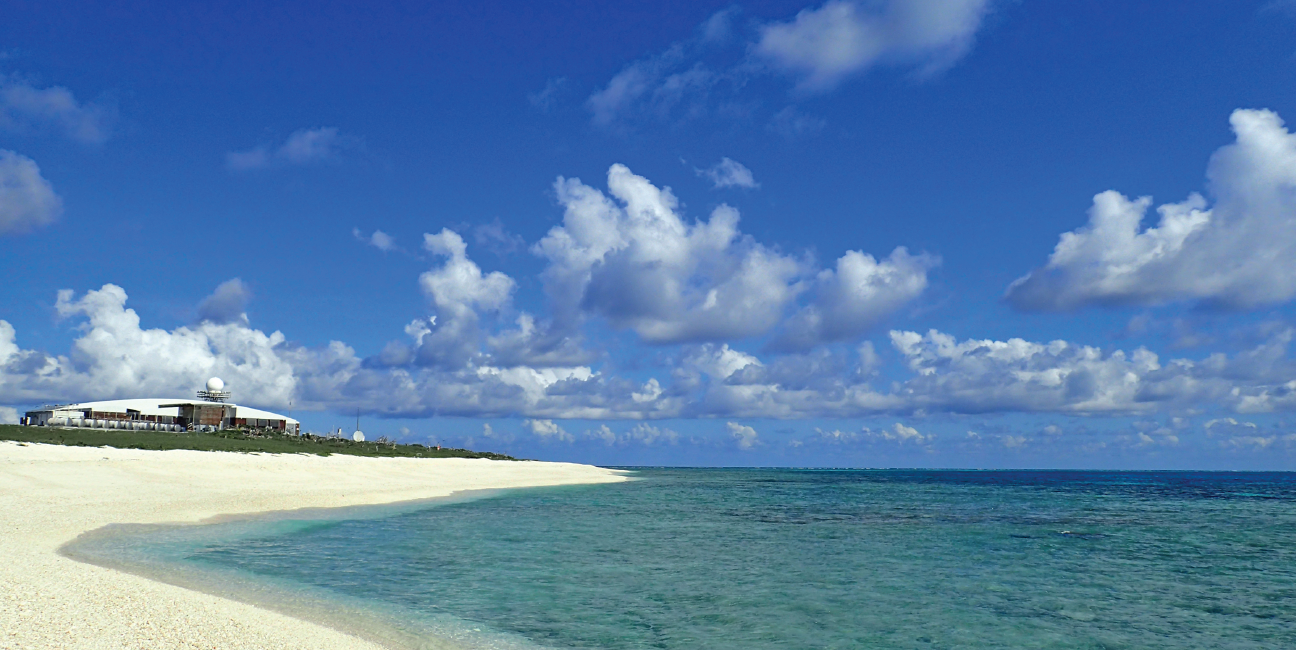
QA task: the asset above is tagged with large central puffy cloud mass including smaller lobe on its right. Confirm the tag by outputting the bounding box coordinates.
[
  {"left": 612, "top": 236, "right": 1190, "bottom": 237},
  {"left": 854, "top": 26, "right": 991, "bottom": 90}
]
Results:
[{"left": 534, "top": 164, "right": 936, "bottom": 348}]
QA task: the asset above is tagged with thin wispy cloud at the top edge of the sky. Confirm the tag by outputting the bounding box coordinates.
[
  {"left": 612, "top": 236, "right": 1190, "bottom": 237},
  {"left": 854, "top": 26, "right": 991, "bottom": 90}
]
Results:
[{"left": 586, "top": 0, "right": 990, "bottom": 128}]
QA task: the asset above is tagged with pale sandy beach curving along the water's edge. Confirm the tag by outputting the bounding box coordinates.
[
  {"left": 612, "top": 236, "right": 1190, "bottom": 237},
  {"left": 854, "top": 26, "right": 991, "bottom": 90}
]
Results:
[{"left": 0, "top": 442, "right": 623, "bottom": 650}]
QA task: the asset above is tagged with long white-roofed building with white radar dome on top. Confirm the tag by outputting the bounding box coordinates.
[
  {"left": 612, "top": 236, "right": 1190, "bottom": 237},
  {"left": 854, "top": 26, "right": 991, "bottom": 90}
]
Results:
[{"left": 22, "top": 377, "right": 301, "bottom": 435}]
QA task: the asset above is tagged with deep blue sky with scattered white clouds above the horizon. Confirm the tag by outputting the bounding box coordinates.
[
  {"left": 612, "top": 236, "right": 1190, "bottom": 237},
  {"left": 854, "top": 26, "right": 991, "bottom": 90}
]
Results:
[{"left": 0, "top": 0, "right": 1296, "bottom": 469}]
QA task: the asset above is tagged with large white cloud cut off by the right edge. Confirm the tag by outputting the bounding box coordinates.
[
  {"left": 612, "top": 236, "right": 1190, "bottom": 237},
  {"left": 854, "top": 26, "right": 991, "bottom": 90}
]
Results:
[{"left": 1006, "top": 110, "right": 1296, "bottom": 309}]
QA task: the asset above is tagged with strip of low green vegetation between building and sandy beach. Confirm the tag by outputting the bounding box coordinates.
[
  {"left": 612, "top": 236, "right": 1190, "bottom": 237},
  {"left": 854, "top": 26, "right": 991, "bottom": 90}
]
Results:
[{"left": 0, "top": 425, "right": 517, "bottom": 461}]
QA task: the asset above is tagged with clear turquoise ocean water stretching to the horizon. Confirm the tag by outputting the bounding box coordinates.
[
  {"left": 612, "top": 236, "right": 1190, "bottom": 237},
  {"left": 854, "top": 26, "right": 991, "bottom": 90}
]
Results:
[{"left": 68, "top": 469, "right": 1296, "bottom": 650}]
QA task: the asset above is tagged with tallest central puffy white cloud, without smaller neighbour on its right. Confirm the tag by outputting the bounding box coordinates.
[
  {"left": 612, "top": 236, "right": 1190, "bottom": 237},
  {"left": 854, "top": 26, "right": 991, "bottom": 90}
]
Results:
[{"left": 534, "top": 164, "right": 801, "bottom": 343}]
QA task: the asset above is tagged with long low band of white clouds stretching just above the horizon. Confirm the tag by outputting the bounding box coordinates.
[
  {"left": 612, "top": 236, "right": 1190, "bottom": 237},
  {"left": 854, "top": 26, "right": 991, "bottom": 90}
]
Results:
[{"left": 0, "top": 284, "right": 1296, "bottom": 422}]
